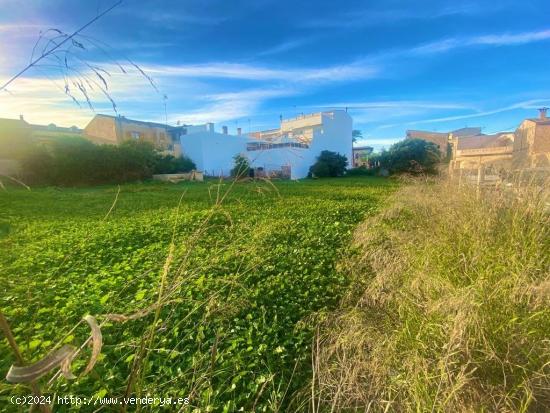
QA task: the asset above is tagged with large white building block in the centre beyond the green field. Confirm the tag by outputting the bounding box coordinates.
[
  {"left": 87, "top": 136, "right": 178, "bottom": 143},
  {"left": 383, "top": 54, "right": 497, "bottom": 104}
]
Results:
[{"left": 181, "top": 110, "right": 352, "bottom": 179}]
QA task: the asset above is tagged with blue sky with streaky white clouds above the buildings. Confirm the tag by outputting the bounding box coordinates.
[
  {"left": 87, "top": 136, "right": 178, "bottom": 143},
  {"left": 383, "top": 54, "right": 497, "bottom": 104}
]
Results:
[{"left": 0, "top": 0, "right": 550, "bottom": 149}]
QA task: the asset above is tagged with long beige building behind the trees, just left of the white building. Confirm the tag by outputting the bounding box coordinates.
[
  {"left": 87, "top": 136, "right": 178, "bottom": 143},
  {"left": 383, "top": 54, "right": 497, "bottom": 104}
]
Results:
[{"left": 84, "top": 115, "right": 186, "bottom": 156}]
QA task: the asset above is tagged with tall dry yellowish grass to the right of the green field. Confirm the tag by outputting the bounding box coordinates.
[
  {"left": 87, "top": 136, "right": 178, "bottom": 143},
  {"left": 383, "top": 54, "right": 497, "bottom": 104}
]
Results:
[{"left": 308, "top": 177, "right": 550, "bottom": 412}]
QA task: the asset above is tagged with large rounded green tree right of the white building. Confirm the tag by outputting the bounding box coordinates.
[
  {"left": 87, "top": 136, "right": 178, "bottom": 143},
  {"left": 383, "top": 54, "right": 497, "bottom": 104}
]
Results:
[{"left": 379, "top": 139, "right": 441, "bottom": 174}]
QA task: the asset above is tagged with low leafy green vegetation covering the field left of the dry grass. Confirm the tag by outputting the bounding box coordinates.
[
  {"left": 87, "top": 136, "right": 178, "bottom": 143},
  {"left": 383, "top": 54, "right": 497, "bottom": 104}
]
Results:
[{"left": 0, "top": 178, "right": 395, "bottom": 411}]
